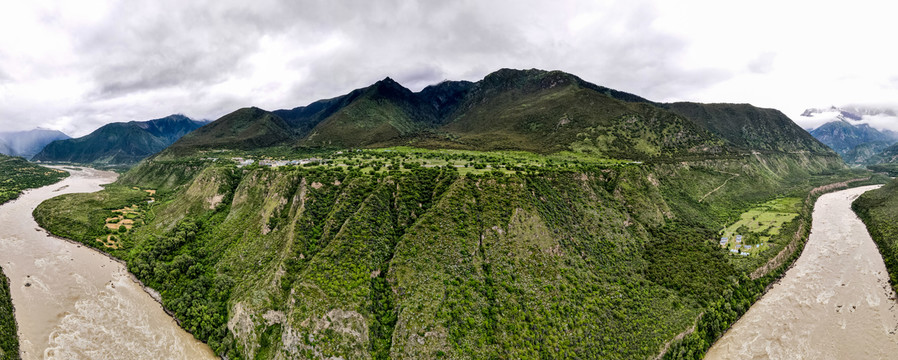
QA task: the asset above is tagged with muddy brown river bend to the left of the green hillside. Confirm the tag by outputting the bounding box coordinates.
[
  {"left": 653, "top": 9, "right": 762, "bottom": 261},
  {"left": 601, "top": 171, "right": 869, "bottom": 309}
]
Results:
[{"left": 0, "top": 169, "right": 215, "bottom": 359}]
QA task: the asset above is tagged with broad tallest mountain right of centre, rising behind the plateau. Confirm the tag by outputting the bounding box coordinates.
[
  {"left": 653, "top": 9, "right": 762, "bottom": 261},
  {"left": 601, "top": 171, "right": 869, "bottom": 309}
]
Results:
[{"left": 440, "top": 70, "right": 719, "bottom": 159}]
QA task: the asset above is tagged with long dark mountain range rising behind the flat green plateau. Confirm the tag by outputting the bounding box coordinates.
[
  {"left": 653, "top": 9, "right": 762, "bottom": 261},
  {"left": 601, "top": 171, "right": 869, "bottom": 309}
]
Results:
[{"left": 164, "top": 69, "right": 834, "bottom": 159}]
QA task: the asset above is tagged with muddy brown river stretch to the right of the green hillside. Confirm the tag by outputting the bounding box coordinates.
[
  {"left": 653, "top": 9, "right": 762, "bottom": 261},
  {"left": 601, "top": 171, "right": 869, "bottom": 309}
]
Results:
[{"left": 707, "top": 186, "right": 898, "bottom": 359}]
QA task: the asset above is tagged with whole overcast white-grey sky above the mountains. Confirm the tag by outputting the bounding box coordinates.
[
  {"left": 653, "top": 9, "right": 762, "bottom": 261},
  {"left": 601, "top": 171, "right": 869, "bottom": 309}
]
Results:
[{"left": 0, "top": 0, "right": 898, "bottom": 136}]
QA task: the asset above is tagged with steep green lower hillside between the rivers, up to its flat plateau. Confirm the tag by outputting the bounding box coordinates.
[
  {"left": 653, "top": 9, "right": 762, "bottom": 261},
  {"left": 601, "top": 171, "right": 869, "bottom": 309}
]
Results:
[{"left": 34, "top": 148, "right": 858, "bottom": 359}]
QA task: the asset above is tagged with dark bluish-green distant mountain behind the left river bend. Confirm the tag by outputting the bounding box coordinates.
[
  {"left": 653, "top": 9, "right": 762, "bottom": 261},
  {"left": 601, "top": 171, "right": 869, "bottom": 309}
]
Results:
[{"left": 32, "top": 115, "right": 206, "bottom": 166}]
